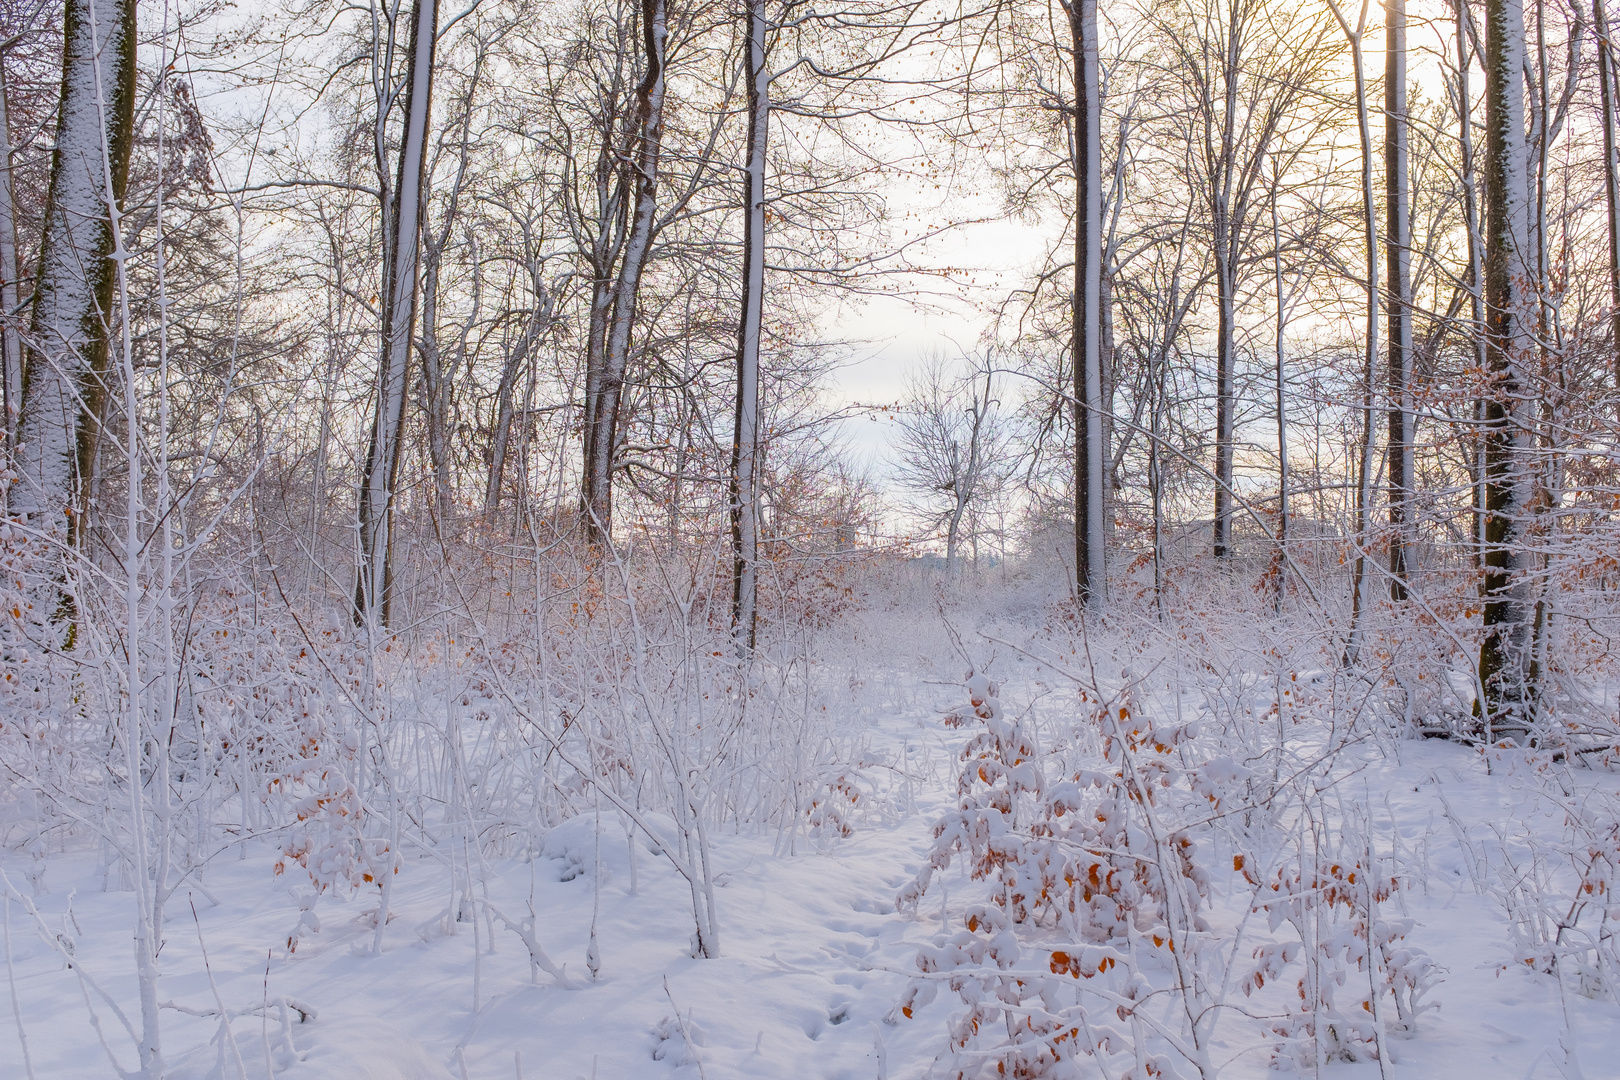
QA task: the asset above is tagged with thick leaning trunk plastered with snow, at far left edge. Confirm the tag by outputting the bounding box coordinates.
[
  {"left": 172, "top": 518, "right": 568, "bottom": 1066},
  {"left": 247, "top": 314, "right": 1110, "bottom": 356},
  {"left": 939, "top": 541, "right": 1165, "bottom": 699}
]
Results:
[{"left": 10, "top": 0, "right": 136, "bottom": 544}]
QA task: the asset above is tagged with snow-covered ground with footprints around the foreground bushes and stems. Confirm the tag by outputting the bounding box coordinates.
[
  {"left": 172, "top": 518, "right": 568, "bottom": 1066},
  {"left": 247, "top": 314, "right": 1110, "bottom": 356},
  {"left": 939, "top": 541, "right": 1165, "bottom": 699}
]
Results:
[{"left": 0, "top": 599, "right": 1620, "bottom": 1080}]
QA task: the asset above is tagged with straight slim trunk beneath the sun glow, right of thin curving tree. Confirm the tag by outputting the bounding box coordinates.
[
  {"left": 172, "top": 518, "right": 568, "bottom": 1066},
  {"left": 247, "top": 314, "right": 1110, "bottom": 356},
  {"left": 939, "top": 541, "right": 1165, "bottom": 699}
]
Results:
[{"left": 1383, "top": 0, "right": 1416, "bottom": 601}]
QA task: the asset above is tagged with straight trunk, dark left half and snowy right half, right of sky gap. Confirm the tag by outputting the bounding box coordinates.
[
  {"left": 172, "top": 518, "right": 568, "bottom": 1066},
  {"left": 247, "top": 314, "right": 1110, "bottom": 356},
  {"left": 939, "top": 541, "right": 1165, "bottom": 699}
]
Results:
[{"left": 1068, "top": 0, "right": 1108, "bottom": 609}]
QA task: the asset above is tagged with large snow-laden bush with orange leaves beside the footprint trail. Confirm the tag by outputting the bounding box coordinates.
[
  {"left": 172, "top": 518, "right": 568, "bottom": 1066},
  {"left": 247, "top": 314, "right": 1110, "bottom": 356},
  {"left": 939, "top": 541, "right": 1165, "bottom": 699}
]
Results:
[{"left": 891, "top": 672, "right": 1233, "bottom": 1080}]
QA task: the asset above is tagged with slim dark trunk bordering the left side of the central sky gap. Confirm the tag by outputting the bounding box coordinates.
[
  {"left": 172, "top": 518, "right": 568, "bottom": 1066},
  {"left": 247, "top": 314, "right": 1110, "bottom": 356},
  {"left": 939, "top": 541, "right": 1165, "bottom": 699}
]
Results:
[{"left": 732, "top": 0, "right": 771, "bottom": 656}]
